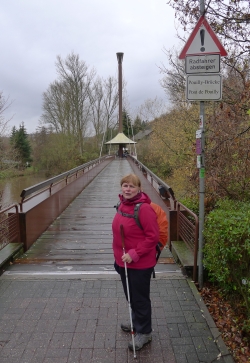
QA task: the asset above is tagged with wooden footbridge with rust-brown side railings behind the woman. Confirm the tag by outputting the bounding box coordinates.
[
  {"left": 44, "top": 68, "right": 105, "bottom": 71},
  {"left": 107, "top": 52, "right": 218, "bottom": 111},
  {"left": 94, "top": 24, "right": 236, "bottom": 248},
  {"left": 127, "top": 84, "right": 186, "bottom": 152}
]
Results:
[{"left": 2, "top": 157, "right": 198, "bottom": 282}]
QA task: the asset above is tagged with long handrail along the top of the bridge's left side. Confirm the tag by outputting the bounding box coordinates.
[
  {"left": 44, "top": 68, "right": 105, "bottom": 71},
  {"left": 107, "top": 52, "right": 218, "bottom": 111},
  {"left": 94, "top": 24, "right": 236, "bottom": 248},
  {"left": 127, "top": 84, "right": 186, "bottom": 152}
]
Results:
[{"left": 20, "top": 156, "right": 107, "bottom": 201}]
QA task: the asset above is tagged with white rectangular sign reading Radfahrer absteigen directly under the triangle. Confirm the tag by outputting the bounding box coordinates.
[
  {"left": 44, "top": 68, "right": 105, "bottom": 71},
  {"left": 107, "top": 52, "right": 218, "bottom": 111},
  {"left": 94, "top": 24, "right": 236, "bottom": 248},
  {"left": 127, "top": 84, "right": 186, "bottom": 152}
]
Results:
[{"left": 185, "top": 54, "right": 220, "bottom": 74}]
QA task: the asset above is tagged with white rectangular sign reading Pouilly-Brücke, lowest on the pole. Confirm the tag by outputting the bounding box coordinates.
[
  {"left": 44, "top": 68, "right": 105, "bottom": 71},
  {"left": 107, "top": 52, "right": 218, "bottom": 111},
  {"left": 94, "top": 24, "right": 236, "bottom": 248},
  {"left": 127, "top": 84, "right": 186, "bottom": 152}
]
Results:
[{"left": 186, "top": 74, "right": 222, "bottom": 101}]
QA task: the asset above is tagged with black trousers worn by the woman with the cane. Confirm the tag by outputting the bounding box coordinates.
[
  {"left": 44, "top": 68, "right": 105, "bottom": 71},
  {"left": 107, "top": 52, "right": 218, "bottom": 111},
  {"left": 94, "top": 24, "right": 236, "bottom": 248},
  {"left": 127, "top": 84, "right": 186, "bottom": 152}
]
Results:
[{"left": 119, "top": 267, "right": 153, "bottom": 334}]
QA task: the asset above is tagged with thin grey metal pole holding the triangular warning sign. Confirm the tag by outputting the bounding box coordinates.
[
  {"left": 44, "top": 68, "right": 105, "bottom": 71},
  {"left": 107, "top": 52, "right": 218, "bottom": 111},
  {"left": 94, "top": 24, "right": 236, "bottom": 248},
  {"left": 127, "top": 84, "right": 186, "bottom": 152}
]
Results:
[{"left": 198, "top": 0, "right": 205, "bottom": 289}]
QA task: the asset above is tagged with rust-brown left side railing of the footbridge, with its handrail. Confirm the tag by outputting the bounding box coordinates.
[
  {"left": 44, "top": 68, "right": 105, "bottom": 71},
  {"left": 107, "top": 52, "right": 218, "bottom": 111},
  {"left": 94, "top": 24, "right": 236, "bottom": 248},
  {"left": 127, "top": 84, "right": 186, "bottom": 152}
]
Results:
[{"left": 0, "top": 156, "right": 113, "bottom": 251}]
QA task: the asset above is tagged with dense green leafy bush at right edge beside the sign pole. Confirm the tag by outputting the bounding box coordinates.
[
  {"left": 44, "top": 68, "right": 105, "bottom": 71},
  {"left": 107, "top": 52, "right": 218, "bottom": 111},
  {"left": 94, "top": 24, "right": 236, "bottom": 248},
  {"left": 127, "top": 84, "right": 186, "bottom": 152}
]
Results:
[{"left": 204, "top": 199, "right": 250, "bottom": 315}]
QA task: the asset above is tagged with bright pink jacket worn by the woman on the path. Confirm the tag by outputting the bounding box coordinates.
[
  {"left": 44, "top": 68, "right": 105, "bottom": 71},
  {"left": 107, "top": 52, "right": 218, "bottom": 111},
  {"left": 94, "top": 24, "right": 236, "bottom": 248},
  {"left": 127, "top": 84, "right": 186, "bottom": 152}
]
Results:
[{"left": 112, "top": 192, "right": 159, "bottom": 269}]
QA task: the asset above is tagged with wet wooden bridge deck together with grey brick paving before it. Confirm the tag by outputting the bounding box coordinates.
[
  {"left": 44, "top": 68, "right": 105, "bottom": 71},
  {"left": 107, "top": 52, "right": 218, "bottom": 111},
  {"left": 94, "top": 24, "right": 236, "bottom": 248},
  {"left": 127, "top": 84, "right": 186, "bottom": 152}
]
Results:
[{"left": 0, "top": 159, "right": 233, "bottom": 363}]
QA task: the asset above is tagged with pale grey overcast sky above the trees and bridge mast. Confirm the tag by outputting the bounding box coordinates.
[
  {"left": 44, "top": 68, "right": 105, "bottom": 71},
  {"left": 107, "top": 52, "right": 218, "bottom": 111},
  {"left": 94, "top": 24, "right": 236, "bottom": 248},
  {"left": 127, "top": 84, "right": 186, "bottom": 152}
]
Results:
[{"left": 0, "top": 0, "right": 184, "bottom": 133}]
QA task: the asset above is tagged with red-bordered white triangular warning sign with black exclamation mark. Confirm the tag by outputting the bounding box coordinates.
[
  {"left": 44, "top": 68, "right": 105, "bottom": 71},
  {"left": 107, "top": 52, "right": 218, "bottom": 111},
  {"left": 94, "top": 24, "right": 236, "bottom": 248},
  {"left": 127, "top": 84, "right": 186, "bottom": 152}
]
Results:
[{"left": 179, "top": 15, "right": 227, "bottom": 59}]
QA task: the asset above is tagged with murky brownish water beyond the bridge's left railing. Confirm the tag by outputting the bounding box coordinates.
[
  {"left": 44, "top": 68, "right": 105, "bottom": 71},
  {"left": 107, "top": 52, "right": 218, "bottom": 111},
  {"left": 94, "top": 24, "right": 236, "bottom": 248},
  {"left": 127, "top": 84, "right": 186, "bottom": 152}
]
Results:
[{"left": 0, "top": 174, "right": 47, "bottom": 208}]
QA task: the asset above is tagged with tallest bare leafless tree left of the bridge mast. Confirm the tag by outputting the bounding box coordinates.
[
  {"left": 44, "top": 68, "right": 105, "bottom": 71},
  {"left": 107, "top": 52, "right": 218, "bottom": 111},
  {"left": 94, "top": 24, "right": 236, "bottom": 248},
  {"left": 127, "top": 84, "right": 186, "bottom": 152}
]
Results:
[{"left": 41, "top": 53, "right": 96, "bottom": 155}]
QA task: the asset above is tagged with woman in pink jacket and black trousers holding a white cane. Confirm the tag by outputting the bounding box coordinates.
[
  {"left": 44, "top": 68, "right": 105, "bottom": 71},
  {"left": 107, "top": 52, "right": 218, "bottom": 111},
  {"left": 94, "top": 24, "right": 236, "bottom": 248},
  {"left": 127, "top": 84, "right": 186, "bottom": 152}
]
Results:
[{"left": 112, "top": 174, "right": 159, "bottom": 350}]
